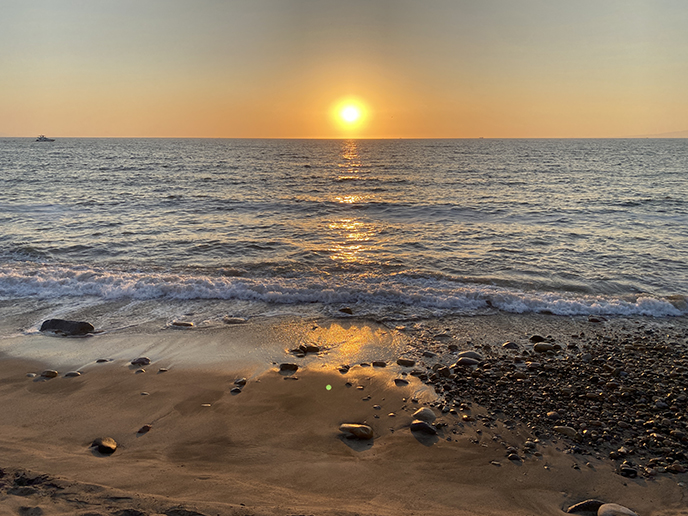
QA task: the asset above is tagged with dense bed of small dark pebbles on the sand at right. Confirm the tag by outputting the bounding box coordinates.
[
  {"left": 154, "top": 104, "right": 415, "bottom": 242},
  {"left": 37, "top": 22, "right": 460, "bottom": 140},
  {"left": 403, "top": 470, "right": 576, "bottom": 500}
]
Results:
[{"left": 402, "top": 320, "right": 688, "bottom": 478}]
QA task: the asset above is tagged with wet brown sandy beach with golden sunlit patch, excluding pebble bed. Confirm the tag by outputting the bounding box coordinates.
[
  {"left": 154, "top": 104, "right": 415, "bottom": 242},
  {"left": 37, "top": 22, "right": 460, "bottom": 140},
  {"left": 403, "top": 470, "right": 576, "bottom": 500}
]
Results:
[{"left": 0, "top": 316, "right": 688, "bottom": 516}]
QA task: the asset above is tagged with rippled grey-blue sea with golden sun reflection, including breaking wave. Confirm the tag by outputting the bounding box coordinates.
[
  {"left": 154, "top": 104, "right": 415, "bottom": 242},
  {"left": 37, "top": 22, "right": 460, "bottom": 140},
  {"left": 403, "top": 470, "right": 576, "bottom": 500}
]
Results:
[{"left": 0, "top": 138, "right": 688, "bottom": 320}]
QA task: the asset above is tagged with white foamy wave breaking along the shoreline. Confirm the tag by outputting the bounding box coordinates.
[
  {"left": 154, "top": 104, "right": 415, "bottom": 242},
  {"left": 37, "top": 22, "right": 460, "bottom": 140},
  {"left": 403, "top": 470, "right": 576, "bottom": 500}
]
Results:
[{"left": 0, "top": 263, "right": 688, "bottom": 317}]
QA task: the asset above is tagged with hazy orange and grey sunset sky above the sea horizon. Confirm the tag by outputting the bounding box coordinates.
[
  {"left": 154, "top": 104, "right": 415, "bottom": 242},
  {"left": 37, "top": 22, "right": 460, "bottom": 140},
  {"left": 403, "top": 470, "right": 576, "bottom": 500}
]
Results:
[{"left": 0, "top": 0, "right": 688, "bottom": 138}]
